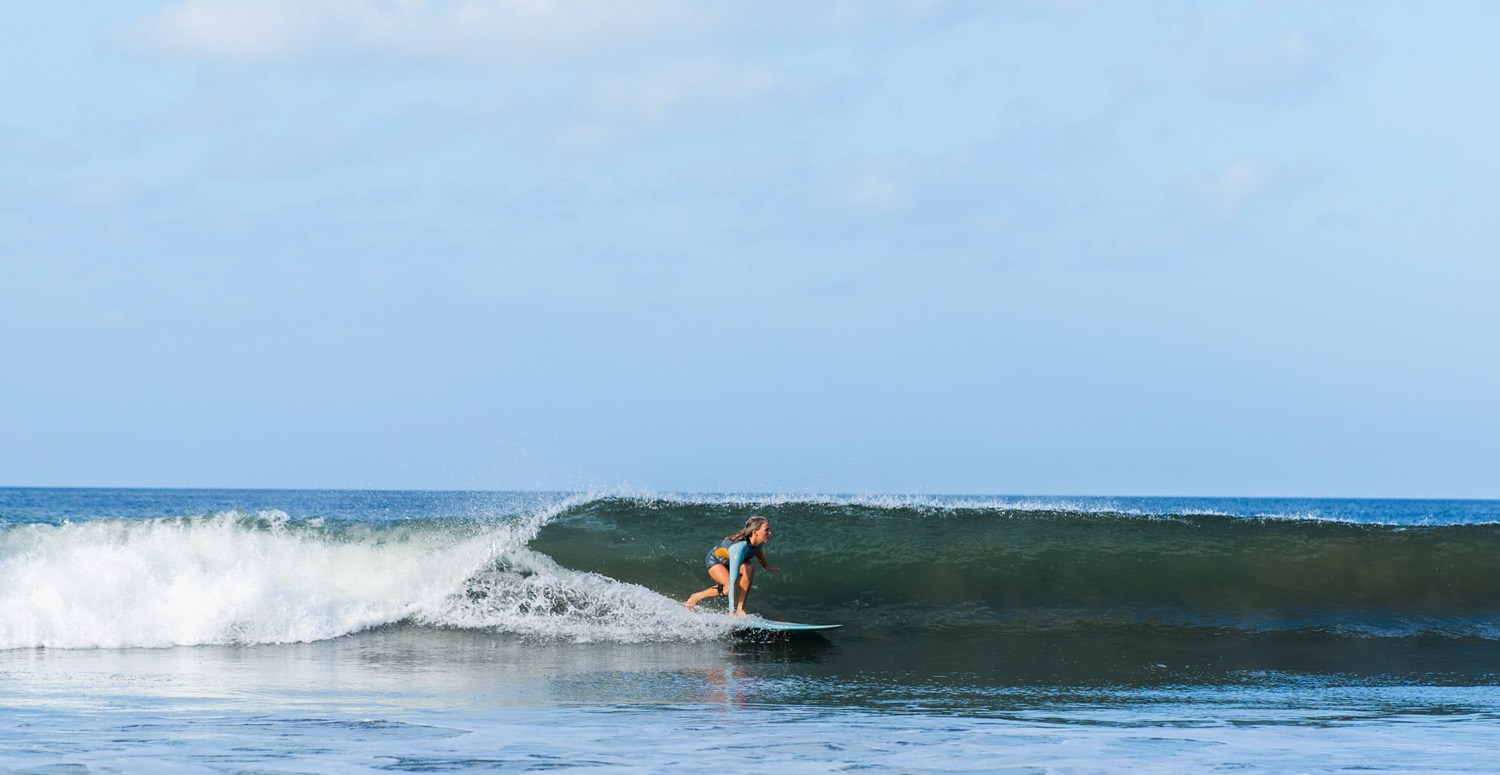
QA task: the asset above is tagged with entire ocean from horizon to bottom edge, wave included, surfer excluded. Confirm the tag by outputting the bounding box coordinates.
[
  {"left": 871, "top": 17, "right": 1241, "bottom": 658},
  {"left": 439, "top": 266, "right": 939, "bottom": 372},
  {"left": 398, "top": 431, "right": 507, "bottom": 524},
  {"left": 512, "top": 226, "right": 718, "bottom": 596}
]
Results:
[{"left": 0, "top": 489, "right": 1500, "bottom": 775}]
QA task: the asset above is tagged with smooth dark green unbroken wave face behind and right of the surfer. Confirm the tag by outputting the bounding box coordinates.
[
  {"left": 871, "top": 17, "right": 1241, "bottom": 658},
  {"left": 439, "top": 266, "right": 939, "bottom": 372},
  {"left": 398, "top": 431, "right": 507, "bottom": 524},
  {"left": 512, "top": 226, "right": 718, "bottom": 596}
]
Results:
[{"left": 531, "top": 499, "right": 1500, "bottom": 639}]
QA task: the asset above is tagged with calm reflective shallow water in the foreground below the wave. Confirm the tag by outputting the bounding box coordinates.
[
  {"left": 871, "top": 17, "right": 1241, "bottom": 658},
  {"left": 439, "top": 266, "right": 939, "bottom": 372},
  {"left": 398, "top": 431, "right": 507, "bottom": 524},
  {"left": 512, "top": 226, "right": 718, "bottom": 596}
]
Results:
[{"left": 0, "top": 628, "right": 1500, "bottom": 774}]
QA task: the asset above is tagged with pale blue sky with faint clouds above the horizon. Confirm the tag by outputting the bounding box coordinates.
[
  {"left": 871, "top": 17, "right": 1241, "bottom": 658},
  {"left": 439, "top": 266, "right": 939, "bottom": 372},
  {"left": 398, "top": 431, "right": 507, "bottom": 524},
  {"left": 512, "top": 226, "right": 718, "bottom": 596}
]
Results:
[{"left": 0, "top": 0, "right": 1500, "bottom": 498}]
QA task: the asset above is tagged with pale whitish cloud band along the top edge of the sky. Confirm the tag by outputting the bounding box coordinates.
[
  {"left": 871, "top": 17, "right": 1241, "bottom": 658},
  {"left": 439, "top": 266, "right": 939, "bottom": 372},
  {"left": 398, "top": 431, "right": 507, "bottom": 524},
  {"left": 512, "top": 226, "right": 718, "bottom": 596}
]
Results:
[{"left": 120, "top": 0, "right": 944, "bottom": 66}]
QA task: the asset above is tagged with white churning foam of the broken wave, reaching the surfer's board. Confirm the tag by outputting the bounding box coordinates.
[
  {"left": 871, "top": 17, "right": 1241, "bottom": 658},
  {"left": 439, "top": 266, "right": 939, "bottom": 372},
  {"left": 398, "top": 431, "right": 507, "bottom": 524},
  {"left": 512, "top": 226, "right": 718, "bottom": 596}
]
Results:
[{"left": 0, "top": 505, "right": 726, "bottom": 649}]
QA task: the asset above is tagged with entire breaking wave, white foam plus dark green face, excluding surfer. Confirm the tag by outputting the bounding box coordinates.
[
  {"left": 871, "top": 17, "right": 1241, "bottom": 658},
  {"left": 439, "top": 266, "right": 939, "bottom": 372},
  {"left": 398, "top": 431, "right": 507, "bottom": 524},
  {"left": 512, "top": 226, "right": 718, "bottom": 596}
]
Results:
[{"left": 0, "top": 490, "right": 1500, "bottom": 649}]
